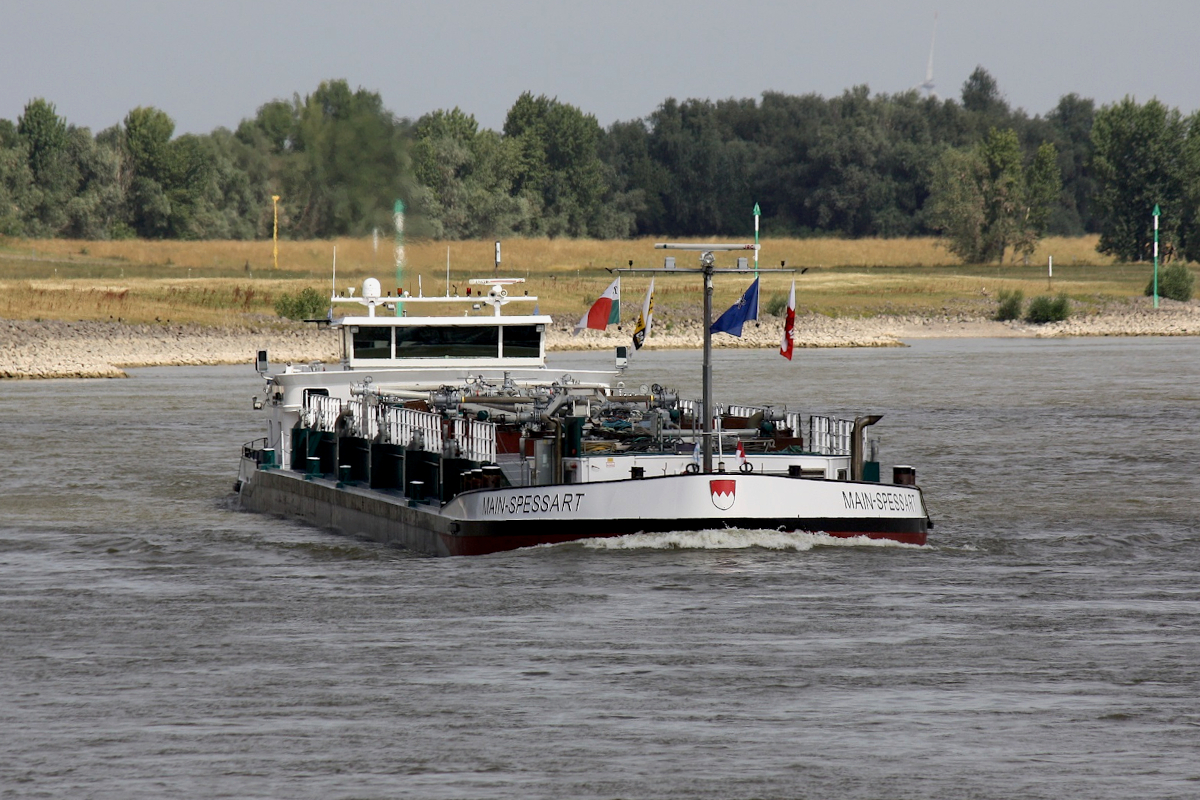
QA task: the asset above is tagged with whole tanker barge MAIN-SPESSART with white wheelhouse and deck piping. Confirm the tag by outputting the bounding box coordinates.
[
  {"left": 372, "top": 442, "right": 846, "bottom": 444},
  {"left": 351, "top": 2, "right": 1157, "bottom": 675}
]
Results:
[{"left": 234, "top": 245, "right": 932, "bottom": 555}]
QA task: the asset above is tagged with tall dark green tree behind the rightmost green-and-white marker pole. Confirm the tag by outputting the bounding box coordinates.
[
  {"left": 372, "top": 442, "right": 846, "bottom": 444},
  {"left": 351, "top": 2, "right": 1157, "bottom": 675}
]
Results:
[{"left": 1092, "top": 97, "right": 1188, "bottom": 261}]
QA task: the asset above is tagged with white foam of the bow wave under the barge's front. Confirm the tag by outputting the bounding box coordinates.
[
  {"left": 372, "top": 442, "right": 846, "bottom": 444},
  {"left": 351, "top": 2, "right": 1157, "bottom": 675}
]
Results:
[{"left": 553, "top": 528, "right": 918, "bottom": 552}]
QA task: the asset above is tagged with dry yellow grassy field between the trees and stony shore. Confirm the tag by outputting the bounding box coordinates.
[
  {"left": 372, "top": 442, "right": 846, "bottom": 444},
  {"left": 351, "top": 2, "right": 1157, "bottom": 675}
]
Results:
[{"left": 0, "top": 236, "right": 1151, "bottom": 325}]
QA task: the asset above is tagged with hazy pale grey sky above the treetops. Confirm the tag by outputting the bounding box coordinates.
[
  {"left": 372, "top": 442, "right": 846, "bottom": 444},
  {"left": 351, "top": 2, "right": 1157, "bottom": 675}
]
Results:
[{"left": 0, "top": 0, "right": 1200, "bottom": 133}]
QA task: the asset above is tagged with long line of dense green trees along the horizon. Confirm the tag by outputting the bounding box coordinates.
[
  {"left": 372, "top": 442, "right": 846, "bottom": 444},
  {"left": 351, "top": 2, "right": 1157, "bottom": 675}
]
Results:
[{"left": 0, "top": 67, "right": 1200, "bottom": 263}]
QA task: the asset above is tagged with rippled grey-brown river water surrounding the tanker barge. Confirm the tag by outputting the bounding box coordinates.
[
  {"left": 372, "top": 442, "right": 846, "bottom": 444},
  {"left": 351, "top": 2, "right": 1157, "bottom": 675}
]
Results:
[{"left": 0, "top": 338, "right": 1200, "bottom": 799}]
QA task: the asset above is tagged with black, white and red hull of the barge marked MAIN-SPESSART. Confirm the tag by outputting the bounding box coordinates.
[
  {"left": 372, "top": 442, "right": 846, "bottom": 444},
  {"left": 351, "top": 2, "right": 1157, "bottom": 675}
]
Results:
[{"left": 239, "top": 469, "right": 929, "bottom": 555}]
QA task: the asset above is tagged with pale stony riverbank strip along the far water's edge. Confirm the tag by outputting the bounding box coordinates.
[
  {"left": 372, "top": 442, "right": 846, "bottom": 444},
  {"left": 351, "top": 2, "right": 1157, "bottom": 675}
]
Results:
[{"left": 0, "top": 297, "right": 1200, "bottom": 379}]
